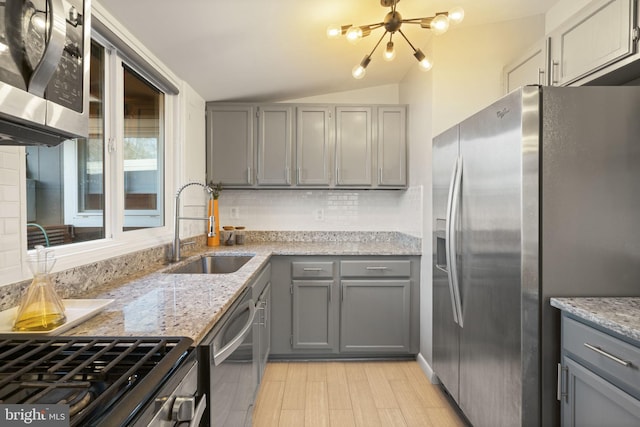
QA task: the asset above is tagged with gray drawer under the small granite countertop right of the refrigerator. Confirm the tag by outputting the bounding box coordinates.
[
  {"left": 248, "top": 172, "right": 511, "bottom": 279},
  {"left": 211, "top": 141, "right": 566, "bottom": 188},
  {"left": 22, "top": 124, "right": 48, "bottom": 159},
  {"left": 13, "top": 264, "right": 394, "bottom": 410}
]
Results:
[{"left": 562, "top": 317, "right": 640, "bottom": 398}]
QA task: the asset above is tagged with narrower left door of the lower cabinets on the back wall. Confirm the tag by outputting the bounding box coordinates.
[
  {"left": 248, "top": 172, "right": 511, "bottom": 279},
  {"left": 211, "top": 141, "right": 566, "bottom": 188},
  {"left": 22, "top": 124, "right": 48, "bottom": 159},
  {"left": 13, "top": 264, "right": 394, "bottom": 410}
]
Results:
[{"left": 291, "top": 280, "right": 337, "bottom": 350}]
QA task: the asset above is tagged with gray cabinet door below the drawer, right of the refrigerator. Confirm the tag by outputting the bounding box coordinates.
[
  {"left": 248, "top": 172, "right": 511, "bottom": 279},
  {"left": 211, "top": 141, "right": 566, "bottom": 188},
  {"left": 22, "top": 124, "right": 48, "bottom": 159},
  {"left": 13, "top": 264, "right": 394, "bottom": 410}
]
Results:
[{"left": 562, "top": 357, "right": 640, "bottom": 427}]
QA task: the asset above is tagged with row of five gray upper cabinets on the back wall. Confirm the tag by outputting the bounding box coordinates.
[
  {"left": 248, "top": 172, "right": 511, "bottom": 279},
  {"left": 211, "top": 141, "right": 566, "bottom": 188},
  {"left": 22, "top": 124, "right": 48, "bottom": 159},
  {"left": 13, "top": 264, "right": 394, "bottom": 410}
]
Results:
[{"left": 207, "top": 102, "right": 408, "bottom": 189}]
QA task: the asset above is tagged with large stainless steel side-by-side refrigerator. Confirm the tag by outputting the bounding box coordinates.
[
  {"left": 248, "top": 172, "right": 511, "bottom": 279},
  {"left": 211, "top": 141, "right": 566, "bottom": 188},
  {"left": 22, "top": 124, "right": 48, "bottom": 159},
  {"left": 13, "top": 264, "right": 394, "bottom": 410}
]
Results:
[{"left": 432, "top": 86, "right": 640, "bottom": 427}]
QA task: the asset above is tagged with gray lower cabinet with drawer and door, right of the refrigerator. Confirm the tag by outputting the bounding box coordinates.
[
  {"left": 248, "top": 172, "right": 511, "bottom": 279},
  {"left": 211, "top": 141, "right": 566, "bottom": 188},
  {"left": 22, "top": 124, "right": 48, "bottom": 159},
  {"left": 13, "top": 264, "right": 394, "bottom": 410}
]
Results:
[{"left": 558, "top": 314, "right": 640, "bottom": 427}]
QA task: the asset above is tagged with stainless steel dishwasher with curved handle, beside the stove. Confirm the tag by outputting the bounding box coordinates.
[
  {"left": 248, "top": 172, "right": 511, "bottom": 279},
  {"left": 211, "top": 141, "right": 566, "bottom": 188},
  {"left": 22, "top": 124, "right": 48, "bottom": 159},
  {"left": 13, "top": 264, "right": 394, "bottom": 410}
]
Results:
[{"left": 198, "top": 288, "right": 258, "bottom": 427}]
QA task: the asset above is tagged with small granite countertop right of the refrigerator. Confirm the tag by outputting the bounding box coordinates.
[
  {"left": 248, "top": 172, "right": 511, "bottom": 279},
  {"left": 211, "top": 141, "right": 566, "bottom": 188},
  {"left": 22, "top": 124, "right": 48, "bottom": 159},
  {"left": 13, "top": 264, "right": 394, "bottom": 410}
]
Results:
[{"left": 551, "top": 297, "right": 640, "bottom": 343}]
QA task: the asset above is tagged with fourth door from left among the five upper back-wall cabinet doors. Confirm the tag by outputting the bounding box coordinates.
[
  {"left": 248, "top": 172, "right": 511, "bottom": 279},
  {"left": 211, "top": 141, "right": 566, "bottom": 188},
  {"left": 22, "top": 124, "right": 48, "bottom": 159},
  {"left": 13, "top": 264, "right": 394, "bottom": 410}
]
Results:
[{"left": 336, "top": 107, "right": 373, "bottom": 186}]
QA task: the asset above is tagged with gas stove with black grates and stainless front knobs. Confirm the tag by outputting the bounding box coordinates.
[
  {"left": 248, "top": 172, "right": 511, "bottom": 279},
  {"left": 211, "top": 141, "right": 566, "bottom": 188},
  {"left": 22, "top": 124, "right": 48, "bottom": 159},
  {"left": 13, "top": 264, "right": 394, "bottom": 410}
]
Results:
[{"left": 0, "top": 336, "right": 206, "bottom": 427}]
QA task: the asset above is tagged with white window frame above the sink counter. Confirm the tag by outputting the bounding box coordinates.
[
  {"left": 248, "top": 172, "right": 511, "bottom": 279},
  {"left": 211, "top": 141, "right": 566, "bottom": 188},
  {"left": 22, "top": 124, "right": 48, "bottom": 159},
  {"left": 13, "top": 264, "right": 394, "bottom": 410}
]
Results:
[{"left": 22, "top": 17, "right": 184, "bottom": 278}]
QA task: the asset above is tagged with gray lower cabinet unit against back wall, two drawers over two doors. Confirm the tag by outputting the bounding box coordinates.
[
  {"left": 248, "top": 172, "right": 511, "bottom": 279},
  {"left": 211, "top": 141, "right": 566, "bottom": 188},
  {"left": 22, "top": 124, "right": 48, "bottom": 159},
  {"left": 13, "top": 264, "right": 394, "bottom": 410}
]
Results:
[{"left": 271, "top": 256, "right": 420, "bottom": 358}]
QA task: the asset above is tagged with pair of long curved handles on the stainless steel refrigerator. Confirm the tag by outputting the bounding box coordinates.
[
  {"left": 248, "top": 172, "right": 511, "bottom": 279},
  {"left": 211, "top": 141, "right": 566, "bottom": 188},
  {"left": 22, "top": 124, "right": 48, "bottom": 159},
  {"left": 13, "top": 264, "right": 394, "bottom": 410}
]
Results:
[{"left": 447, "top": 157, "right": 464, "bottom": 328}]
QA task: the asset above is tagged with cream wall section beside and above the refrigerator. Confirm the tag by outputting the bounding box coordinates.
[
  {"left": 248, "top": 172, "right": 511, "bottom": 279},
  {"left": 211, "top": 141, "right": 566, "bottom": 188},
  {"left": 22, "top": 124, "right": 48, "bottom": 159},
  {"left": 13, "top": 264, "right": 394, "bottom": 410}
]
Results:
[{"left": 400, "top": 15, "right": 544, "bottom": 380}]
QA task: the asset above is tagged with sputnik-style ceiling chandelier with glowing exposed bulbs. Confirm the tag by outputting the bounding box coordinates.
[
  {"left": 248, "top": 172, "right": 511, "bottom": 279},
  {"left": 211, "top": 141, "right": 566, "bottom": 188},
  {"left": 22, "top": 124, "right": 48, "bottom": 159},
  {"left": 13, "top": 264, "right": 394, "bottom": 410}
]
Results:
[{"left": 327, "top": 0, "right": 464, "bottom": 79}]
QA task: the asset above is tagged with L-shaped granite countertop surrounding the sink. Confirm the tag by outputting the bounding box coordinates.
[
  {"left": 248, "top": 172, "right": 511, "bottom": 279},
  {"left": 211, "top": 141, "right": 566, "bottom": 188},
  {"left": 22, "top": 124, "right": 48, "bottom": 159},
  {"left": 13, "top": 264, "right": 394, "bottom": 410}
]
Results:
[{"left": 65, "top": 242, "right": 420, "bottom": 344}]
